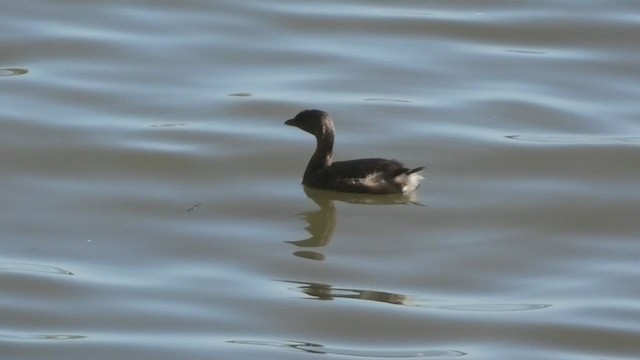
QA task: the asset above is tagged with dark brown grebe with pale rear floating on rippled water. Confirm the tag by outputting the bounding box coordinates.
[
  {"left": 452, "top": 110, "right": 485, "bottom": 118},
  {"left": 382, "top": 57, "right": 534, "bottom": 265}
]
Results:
[{"left": 285, "top": 110, "right": 424, "bottom": 194}]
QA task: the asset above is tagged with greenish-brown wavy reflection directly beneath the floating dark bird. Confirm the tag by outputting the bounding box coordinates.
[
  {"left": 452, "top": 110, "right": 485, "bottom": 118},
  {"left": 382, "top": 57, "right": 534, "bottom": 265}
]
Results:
[{"left": 285, "top": 187, "right": 423, "bottom": 260}]
